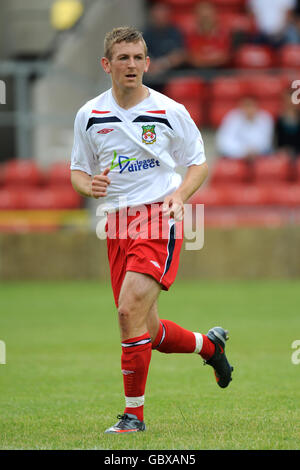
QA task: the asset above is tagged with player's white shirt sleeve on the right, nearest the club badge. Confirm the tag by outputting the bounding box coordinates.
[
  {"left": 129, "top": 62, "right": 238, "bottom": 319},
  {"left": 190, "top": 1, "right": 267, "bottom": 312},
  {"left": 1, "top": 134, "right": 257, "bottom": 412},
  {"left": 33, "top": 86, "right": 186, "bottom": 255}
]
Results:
[{"left": 173, "top": 105, "right": 206, "bottom": 167}]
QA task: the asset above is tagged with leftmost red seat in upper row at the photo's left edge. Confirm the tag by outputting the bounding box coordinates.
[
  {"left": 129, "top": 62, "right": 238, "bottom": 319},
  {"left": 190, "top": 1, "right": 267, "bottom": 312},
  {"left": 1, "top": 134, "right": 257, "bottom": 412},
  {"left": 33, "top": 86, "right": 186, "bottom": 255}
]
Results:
[{"left": 3, "top": 160, "right": 44, "bottom": 186}]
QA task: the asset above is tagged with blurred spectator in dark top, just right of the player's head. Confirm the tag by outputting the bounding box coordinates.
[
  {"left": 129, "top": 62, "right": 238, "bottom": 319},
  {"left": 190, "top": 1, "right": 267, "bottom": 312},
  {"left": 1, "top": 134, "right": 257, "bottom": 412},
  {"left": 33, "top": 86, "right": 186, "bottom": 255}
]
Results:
[{"left": 143, "top": 3, "right": 185, "bottom": 76}]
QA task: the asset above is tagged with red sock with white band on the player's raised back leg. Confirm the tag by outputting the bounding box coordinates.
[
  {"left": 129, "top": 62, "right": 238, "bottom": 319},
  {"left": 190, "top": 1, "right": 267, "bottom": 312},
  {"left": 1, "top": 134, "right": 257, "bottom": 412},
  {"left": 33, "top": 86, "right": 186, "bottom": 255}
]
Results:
[{"left": 152, "top": 320, "right": 215, "bottom": 360}]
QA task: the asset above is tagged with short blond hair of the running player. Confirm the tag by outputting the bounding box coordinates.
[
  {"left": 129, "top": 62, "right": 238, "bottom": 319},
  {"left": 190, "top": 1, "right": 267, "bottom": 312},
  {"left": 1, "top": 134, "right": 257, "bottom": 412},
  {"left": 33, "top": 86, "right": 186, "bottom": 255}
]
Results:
[{"left": 104, "top": 26, "right": 148, "bottom": 60}]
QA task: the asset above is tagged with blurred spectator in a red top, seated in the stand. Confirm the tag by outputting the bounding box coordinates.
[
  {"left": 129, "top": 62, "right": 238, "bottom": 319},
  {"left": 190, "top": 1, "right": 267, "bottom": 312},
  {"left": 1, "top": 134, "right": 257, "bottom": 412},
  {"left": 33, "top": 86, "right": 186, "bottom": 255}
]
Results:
[{"left": 186, "top": 1, "right": 231, "bottom": 67}]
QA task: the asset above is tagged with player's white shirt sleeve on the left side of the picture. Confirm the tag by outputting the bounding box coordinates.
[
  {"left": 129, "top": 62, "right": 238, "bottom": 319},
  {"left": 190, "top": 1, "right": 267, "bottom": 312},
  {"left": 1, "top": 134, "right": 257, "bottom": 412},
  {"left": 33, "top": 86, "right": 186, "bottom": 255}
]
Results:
[{"left": 71, "top": 109, "right": 97, "bottom": 175}]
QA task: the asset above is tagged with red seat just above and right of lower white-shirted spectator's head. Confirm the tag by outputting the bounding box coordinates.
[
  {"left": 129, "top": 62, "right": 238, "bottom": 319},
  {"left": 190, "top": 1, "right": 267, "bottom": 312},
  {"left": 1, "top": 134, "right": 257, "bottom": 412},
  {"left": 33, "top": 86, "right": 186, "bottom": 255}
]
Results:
[{"left": 245, "top": 74, "right": 285, "bottom": 100}]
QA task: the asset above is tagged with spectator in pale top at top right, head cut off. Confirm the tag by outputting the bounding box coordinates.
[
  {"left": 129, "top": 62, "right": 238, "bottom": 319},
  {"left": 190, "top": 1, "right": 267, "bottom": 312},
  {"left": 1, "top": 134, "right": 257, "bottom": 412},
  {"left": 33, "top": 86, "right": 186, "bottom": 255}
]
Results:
[{"left": 248, "top": 0, "right": 296, "bottom": 48}]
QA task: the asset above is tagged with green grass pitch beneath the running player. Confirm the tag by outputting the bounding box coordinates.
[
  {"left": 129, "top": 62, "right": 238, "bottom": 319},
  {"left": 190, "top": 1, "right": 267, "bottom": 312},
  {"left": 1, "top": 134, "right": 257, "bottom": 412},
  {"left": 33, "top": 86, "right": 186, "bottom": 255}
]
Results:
[{"left": 0, "top": 281, "right": 300, "bottom": 450}]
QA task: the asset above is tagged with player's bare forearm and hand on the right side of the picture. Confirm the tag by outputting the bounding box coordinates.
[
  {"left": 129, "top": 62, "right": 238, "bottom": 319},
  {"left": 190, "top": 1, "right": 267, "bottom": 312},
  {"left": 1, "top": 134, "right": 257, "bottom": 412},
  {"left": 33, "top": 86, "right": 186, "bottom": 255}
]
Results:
[{"left": 163, "top": 162, "right": 208, "bottom": 220}]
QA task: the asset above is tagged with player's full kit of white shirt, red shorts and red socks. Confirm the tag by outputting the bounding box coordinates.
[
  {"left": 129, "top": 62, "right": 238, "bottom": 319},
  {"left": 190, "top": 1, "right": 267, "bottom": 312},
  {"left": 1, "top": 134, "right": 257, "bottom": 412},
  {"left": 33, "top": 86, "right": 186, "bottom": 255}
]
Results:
[{"left": 71, "top": 80, "right": 230, "bottom": 433}]
